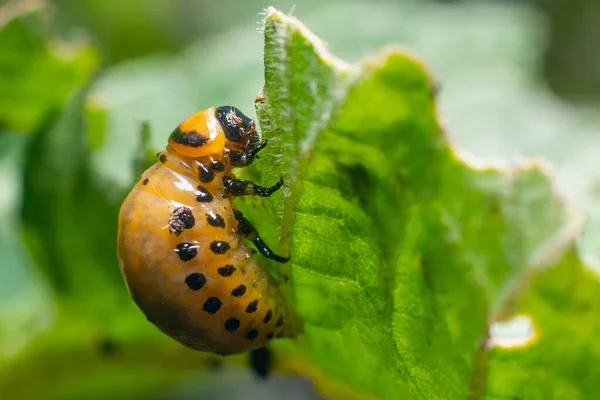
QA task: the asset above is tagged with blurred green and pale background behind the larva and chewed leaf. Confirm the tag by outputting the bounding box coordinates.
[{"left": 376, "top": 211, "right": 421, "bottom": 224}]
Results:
[{"left": 0, "top": 0, "right": 600, "bottom": 399}]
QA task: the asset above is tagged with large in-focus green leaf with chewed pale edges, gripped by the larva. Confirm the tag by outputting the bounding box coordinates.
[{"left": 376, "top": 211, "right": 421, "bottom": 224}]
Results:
[{"left": 236, "top": 9, "right": 596, "bottom": 399}]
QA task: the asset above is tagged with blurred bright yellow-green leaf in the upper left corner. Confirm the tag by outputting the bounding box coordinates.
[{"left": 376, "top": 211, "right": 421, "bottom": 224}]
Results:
[{"left": 0, "top": 1, "right": 98, "bottom": 132}]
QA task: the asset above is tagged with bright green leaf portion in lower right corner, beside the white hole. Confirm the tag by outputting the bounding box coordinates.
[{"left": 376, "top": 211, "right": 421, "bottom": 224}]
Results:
[{"left": 486, "top": 252, "right": 600, "bottom": 400}]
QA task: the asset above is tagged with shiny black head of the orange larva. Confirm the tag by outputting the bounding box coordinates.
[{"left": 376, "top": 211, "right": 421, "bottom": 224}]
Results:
[{"left": 215, "top": 106, "right": 258, "bottom": 148}]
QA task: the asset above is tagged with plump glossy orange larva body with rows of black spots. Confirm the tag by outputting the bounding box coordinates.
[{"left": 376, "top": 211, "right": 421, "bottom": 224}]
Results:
[{"left": 118, "top": 108, "right": 300, "bottom": 354}]
